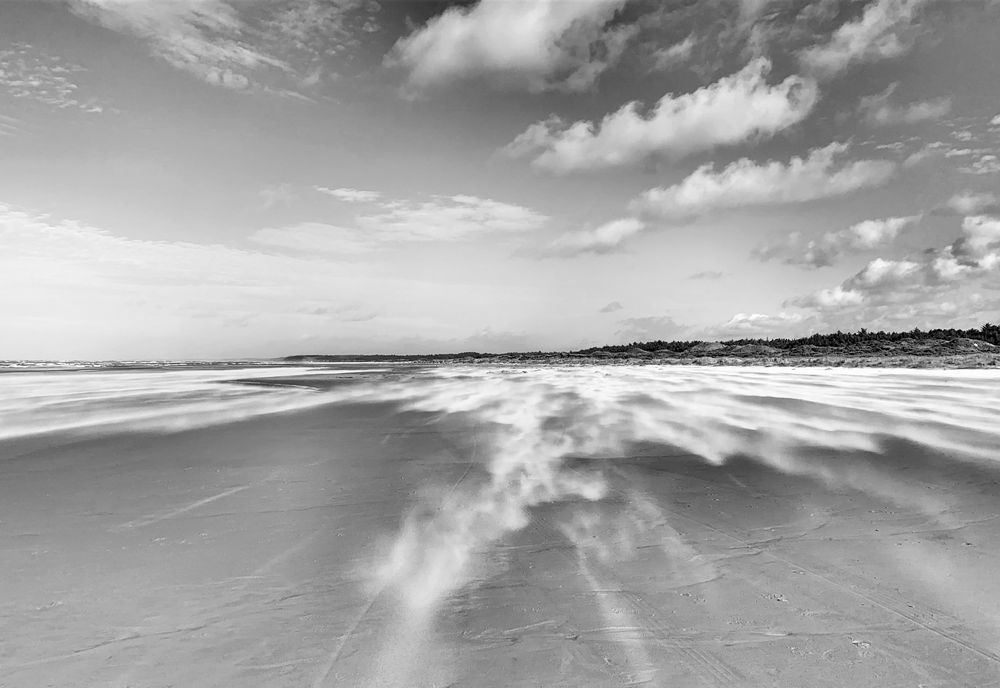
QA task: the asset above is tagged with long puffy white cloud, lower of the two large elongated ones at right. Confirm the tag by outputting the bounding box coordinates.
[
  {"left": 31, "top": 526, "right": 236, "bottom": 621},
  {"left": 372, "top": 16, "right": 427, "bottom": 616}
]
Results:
[{"left": 632, "top": 142, "right": 897, "bottom": 219}]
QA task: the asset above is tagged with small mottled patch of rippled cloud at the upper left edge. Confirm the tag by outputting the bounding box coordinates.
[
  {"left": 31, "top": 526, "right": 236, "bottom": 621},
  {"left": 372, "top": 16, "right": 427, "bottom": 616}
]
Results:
[{"left": 0, "top": 43, "right": 107, "bottom": 113}]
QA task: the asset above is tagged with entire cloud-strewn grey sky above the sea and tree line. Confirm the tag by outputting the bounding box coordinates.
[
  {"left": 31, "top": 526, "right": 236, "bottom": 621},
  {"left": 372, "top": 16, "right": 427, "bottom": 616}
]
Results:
[{"left": 0, "top": 0, "right": 1000, "bottom": 360}]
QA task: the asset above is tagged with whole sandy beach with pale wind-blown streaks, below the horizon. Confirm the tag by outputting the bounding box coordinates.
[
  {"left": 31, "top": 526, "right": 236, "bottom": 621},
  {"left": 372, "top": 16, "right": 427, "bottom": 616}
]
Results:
[{"left": 0, "top": 367, "right": 1000, "bottom": 688}]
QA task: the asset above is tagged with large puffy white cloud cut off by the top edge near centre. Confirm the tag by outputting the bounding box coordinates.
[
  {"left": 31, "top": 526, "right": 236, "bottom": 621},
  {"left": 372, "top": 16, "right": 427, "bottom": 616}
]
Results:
[{"left": 386, "top": 0, "right": 635, "bottom": 96}]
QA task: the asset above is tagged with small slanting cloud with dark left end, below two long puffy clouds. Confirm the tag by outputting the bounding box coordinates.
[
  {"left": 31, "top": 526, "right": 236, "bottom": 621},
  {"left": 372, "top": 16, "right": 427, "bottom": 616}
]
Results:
[{"left": 754, "top": 215, "right": 920, "bottom": 268}]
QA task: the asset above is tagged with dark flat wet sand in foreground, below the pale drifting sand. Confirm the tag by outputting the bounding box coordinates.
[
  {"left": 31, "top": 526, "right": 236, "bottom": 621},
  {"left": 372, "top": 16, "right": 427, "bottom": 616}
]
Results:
[{"left": 0, "top": 390, "right": 1000, "bottom": 688}]
